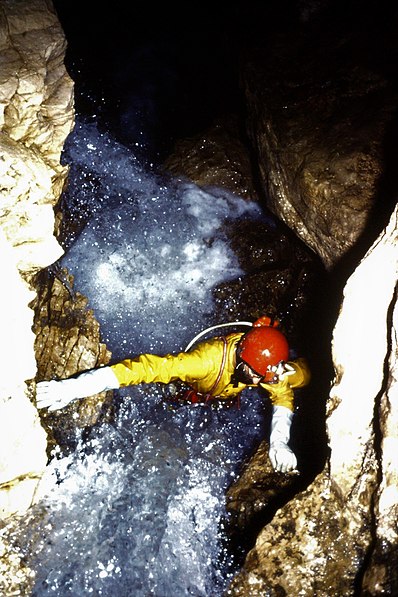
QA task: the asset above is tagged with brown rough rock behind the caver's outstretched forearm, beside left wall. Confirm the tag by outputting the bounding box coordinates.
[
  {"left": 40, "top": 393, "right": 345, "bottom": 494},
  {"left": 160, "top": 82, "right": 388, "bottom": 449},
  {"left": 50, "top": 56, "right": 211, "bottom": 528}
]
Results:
[{"left": 33, "top": 266, "right": 112, "bottom": 442}]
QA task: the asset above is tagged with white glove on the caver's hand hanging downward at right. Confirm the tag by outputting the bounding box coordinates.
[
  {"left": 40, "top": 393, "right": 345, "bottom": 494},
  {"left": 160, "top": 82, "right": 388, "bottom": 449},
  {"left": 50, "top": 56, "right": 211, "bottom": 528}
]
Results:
[{"left": 269, "top": 406, "right": 297, "bottom": 473}]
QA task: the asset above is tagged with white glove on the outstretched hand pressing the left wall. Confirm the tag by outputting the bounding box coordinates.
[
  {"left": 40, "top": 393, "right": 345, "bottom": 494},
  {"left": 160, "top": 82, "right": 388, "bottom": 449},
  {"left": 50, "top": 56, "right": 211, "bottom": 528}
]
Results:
[{"left": 36, "top": 367, "right": 120, "bottom": 411}]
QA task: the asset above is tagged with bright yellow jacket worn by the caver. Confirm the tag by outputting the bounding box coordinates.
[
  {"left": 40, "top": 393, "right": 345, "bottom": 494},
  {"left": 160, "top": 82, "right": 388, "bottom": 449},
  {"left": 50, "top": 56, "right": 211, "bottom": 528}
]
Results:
[{"left": 111, "top": 333, "right": 310, "bottom": 410}]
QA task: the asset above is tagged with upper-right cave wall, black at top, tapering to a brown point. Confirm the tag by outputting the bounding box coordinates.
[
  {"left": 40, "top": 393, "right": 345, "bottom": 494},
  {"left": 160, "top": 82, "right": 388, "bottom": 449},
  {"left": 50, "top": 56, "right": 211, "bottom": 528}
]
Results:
[{"left": 241, "top": 0, "right": 398, "bottom": 270}]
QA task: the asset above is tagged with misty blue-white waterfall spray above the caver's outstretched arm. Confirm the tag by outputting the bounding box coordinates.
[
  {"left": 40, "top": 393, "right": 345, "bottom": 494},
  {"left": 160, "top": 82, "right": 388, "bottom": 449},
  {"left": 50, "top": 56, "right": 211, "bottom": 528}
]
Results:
[{"left": 62, "top": 118, "right": 261, "bottom": 360}]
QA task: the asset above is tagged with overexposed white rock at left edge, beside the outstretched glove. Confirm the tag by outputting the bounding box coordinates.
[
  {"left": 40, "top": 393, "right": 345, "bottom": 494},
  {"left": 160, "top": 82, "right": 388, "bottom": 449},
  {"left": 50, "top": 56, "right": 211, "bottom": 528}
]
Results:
[{"left": 0, "top": 231, "right": 47, "bottom": 518}]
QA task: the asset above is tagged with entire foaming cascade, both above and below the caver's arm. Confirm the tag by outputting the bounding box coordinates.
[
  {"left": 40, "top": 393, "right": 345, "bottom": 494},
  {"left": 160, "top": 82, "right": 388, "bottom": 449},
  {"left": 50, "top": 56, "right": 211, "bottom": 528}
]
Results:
[{"left": 3, "top": 118, "right": 270, "bottom": 597}]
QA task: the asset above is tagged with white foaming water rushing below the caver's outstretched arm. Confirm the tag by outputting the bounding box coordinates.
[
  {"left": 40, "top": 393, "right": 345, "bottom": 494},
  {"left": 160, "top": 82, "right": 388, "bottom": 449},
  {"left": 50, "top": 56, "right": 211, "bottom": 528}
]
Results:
[{"left": 8, "top": 386, "right": 264, "bottom": 597}]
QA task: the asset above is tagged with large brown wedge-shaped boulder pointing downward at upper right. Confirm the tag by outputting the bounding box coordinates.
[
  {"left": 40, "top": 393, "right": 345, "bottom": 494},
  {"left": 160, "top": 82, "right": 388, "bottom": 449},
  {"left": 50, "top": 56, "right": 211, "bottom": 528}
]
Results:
[{"left": 242, "top": 25, "right": 397, "bottom": 269}]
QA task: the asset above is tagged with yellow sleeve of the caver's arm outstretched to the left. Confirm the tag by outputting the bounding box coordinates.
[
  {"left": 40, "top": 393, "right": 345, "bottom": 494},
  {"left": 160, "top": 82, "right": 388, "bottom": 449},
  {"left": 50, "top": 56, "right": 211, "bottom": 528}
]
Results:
[{"left": 111, "top": 352, "right": 213, "bottom": 387}]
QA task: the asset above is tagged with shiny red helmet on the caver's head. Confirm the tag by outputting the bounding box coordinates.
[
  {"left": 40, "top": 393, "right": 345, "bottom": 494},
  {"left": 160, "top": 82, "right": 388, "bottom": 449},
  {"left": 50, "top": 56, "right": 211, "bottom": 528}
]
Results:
[{"left": 239, "top": 316, "right": 289, "bottom": 381}]
